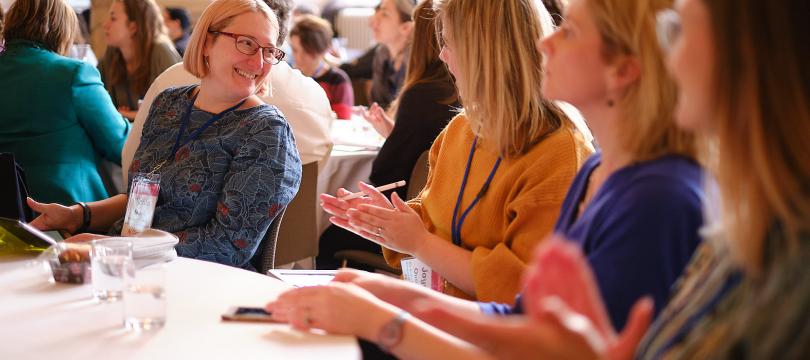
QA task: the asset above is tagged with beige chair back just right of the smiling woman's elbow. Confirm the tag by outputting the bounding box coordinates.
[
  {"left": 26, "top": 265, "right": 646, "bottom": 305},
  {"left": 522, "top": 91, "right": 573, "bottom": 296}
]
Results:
[{"left": 276, "top": 162, "right": 319, "bottom": 265}]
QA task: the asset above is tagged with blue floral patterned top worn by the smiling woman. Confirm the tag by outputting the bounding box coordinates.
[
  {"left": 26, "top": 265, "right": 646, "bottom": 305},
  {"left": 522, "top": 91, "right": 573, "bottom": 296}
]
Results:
[{"left": 110, "top": 85, "right": 301, "bottom": 269}]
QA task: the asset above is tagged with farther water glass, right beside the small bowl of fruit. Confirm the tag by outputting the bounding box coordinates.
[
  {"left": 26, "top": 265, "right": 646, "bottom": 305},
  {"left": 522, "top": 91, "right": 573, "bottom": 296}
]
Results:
[{"left": 90, "top": 239, "right": 134, "bottom": 302}]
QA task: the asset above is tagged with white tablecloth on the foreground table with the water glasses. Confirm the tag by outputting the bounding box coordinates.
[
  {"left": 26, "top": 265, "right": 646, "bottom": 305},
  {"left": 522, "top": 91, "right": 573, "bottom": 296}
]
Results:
[{"left": 0, "top": 256, "right": 360, "bottom": 360}]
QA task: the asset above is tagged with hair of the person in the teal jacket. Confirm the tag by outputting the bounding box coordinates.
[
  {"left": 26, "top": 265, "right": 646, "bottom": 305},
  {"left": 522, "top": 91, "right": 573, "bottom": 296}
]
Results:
[{"left": 0, "top": 0, "right": 79, "bottom": 55}]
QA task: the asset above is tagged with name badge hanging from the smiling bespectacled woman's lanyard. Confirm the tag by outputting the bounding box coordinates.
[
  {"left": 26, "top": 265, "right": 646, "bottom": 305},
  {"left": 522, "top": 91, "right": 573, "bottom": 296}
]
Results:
[{"left": 121, "top": 173, "right": 160, "bottom": 236}]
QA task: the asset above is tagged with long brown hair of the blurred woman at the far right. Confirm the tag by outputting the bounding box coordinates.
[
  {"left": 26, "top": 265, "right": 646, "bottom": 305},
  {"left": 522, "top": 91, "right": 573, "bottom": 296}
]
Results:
[{"left": 704, "top": 0, "right": 810, "bottom": 273}]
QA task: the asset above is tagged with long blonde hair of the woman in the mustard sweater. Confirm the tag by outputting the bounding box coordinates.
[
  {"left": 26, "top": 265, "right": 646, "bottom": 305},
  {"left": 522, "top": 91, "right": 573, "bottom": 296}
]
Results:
[{"left": 434, "top": 0, "right": 571, "bottom": 158}]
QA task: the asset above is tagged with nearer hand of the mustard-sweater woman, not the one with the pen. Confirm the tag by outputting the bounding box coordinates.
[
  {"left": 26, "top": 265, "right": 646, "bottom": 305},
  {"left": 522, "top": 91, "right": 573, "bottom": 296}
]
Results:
[{"left": 346, "top": 188, "right": 431, "bottom": 257}]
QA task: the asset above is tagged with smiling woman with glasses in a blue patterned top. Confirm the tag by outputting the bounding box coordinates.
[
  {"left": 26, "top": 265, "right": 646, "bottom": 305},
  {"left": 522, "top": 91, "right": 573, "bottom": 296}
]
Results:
[{"left": 29, "top": 0, "right": 301, "bottom": 269}]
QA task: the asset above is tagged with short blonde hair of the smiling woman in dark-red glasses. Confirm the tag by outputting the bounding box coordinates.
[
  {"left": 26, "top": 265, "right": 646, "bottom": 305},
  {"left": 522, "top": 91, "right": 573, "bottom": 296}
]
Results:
[{"left": 183, "top": 0, "right": 279, "bottom": 80}]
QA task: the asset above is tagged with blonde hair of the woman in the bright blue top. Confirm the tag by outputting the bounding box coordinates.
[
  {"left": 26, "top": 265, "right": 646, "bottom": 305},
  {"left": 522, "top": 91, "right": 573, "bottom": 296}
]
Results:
[{"left": 587, "top": 0, "right": 697, "bottom": 161}]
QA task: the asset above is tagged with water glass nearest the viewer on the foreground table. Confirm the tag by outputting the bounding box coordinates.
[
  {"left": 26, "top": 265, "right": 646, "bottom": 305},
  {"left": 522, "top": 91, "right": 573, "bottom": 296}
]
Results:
[{"left": 124, "top": 264, "right": 166, "bottom": 332}]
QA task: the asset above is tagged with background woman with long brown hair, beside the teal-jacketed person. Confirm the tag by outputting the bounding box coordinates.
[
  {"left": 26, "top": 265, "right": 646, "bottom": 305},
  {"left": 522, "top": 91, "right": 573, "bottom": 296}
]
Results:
[{"left": 98, "top": 0, "right": 180, "bottom": 121}]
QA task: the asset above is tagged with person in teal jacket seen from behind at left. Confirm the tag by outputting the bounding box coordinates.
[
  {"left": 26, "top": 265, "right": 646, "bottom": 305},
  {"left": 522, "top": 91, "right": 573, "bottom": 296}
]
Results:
[{"left": 0, "top": 0, "right": 130, "bottom": 204}]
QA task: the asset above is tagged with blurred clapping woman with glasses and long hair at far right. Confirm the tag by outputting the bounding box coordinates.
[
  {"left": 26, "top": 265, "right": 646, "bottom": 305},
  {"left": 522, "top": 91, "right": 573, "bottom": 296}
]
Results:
[{"left": 378, "top": 0, "right": 810, "bottom": 359}]
